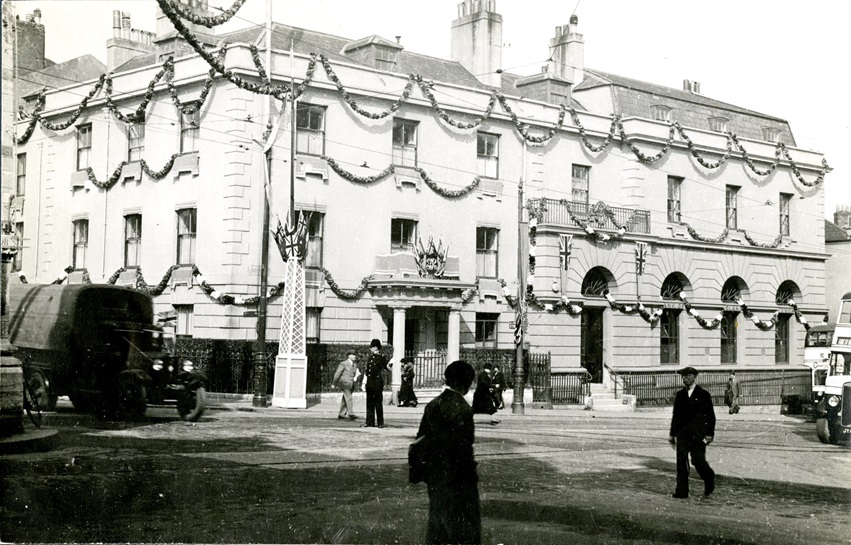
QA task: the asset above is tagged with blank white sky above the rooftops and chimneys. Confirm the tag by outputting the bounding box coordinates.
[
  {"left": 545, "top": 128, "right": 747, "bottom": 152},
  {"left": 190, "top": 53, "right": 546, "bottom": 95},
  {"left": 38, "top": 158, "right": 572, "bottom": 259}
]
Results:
[{"left": 10, "top": 0, "right": 851, "bottom": 219}]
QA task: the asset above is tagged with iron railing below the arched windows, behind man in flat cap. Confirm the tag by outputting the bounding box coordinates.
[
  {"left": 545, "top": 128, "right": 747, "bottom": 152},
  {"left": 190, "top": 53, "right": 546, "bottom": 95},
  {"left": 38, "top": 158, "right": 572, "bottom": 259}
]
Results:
[{"left": 618, "top": 369, "right": 812, "bottom": 407}]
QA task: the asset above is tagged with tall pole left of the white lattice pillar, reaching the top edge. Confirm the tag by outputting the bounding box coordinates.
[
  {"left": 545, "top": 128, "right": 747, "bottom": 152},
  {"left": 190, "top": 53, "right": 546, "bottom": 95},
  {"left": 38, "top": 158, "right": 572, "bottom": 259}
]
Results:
[{"left": 251, "top": 0, "right": 273, "bottom": 407}]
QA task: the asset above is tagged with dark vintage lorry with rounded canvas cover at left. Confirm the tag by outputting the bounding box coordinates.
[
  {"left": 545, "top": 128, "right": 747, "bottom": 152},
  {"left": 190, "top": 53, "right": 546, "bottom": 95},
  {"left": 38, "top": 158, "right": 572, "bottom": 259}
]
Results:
[{"left": 9, "top": 284, "right": 206, "bottom": 420}]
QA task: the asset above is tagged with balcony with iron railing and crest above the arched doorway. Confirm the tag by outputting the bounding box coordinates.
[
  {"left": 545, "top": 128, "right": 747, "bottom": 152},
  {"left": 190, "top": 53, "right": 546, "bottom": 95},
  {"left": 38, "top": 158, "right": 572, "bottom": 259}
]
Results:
[{"left": 534, "top": 198, "right": 650, "bottom": 234}]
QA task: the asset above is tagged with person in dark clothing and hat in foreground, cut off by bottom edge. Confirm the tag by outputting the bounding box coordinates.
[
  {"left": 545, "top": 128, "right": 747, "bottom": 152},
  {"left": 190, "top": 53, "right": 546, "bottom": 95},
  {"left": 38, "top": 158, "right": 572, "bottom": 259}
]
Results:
[{"left": 417, "top": 361, "right": 482, "bottom": 545}]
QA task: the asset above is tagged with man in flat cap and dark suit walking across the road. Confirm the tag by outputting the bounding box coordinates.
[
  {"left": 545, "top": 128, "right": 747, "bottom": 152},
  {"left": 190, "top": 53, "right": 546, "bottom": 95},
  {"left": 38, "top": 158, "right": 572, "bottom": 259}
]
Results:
[{"left": 668, "top": 367, "right": 715, "bottom": 498}]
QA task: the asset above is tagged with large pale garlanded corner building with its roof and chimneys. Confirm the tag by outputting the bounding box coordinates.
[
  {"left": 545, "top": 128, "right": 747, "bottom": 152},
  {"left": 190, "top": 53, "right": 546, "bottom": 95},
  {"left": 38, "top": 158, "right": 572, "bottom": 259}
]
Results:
[{"left": 4, "top": 0, "right": 827, "bottom": 388}]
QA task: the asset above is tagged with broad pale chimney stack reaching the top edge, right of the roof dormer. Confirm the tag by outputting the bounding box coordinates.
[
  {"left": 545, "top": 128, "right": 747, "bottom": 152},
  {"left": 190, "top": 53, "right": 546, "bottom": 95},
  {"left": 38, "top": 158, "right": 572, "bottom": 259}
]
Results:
[{"left": 451, "top": 0, "right": 502, "bottom": 87}]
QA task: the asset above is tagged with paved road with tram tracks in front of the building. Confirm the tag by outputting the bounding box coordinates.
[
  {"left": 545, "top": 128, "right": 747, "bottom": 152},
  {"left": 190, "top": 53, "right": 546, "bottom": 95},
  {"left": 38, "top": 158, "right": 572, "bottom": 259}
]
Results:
[{"left": 0, "top": 406, "right": 851, "bottom": 545}]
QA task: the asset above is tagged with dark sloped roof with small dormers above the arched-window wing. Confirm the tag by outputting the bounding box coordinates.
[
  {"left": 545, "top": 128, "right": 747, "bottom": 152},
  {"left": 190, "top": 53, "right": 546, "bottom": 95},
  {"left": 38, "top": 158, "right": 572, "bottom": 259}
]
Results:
[{"left": 573, "top": 68, "right": 795, "bottom": 146}]
